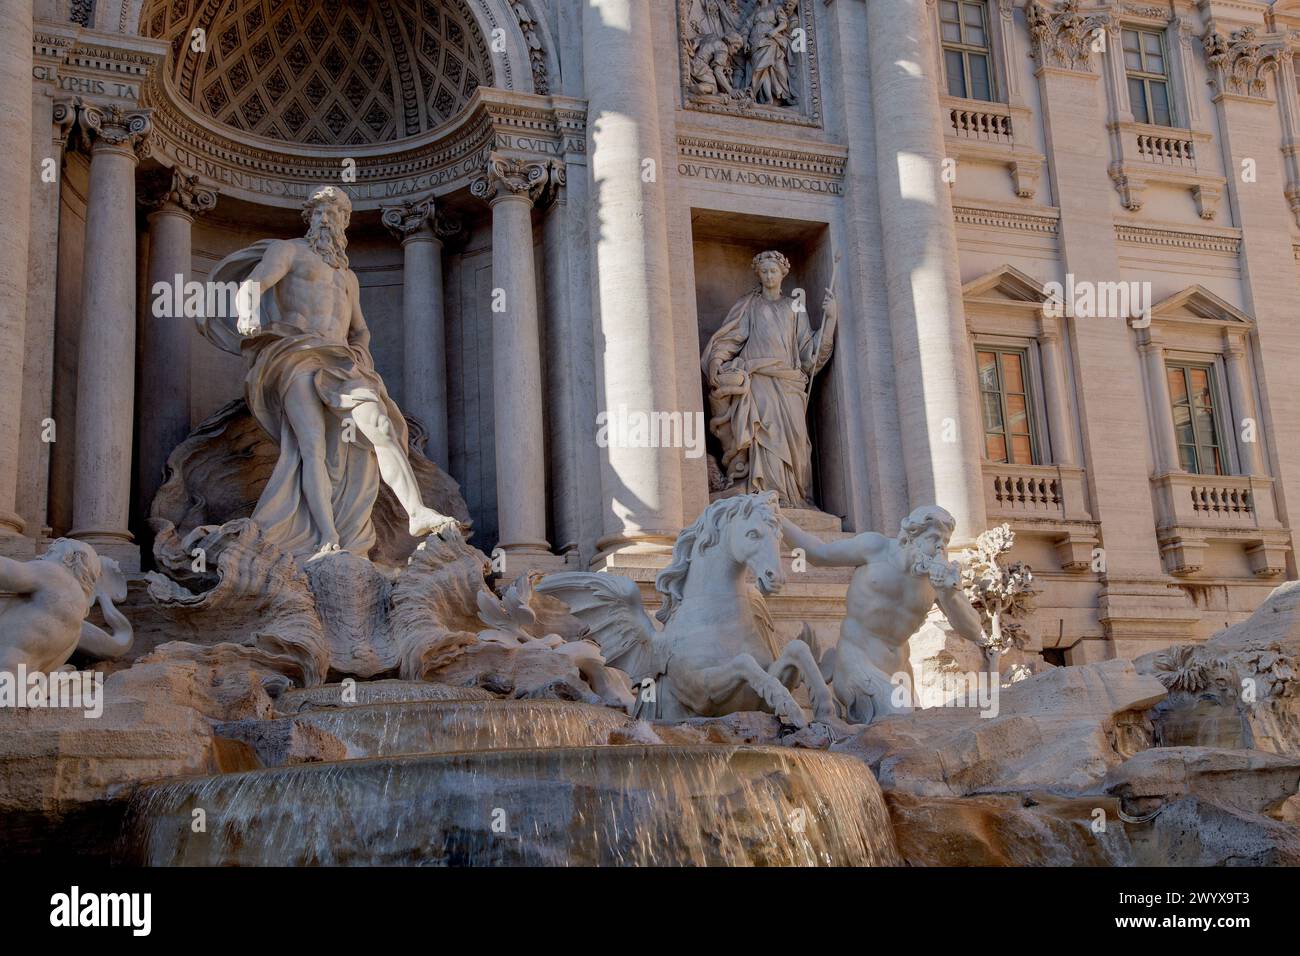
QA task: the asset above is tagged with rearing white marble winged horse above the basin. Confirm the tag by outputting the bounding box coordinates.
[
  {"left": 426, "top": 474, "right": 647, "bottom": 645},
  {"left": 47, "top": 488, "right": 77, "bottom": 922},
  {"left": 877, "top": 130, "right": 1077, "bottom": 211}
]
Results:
[{"left": 537, "top": 492, "right": 835, "bottom": 727}]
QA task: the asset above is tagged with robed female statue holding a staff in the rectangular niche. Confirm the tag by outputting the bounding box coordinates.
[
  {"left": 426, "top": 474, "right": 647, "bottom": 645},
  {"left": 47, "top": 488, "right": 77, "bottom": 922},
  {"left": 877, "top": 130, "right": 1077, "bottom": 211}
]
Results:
[{"left": 701, "top": 251, "right": 836, "bottom": 507}]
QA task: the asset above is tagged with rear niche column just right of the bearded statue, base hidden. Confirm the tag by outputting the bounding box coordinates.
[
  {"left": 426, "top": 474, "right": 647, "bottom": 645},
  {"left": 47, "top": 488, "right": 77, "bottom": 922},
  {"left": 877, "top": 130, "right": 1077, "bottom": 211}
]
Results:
[{"left": 384, "top": 196, "right": 447, "bottom": 470}]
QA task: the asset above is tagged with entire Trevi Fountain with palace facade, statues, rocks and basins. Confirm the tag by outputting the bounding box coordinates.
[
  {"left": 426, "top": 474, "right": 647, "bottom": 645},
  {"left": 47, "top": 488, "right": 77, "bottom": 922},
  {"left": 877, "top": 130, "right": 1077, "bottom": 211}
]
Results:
[{"left": 0, "top": 0, "right": 1300, "bottom": 868}]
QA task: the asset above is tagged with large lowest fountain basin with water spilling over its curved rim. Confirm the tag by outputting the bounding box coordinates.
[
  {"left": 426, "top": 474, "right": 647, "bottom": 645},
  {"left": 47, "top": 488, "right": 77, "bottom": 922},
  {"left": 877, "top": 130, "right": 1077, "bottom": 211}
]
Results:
[{"left": 118, "top": 745, "right": 898, "bottom": 866}]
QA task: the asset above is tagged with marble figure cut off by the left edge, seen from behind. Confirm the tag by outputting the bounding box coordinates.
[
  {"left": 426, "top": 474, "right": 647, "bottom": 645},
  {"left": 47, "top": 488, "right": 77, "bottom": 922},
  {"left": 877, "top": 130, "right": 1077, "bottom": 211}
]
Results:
[{"left": 0, "top": 537, "right": 134, "bottom": 674}]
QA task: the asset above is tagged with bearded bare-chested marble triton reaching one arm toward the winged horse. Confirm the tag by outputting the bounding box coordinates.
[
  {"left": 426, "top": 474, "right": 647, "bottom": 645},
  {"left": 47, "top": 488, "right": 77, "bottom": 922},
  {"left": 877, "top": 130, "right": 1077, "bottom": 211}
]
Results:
[{"left": 781, "top": 505, "right": 984, "bottom": 723}]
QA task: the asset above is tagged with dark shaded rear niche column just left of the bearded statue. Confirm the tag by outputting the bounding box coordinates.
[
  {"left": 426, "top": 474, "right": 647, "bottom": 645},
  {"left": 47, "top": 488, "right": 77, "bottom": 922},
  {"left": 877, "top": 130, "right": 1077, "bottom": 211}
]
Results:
[{"left": 137, "top": 169, "right": 217, "bottom": 515}]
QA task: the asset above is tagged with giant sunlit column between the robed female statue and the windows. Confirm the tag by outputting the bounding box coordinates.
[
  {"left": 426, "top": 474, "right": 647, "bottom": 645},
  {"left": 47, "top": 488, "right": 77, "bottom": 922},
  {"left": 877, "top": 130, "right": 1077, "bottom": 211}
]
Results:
[{"left": 867, "top": 0, "right": 984, "bottom": 542}]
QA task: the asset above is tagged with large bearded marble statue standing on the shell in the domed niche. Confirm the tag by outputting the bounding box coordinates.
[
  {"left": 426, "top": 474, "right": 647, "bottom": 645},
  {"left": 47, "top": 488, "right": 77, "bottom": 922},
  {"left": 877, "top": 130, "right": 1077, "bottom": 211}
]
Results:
[{"left": 199, "top": 186, "right": 455, "bottom": 557}]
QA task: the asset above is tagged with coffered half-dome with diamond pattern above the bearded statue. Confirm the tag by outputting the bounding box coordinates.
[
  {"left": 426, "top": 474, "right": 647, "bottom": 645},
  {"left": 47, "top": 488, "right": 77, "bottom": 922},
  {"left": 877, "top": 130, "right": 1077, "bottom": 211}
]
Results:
[{"left": 143, "top": 0, "right": 493, "bottom": 146}]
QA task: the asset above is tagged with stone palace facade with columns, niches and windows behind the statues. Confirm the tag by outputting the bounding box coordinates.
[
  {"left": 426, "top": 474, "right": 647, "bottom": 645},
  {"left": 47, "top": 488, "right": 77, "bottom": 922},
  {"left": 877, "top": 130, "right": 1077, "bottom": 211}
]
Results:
[{"left": 0, "top": 0, "right": 1300, "bottom": 663}]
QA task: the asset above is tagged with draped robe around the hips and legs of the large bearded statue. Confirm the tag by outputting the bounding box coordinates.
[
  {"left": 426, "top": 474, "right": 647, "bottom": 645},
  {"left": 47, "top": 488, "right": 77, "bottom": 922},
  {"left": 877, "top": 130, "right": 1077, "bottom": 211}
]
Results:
[{"left": 199, "top": 239, "right": 407, "bottom": 557}]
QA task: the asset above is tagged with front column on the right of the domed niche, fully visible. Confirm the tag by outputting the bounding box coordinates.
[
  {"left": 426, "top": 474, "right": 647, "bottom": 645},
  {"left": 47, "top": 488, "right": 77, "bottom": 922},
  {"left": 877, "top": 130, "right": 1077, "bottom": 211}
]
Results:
[{"left": 469, "top": 153, "right": 550, "bottom": 553}]
